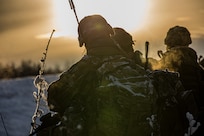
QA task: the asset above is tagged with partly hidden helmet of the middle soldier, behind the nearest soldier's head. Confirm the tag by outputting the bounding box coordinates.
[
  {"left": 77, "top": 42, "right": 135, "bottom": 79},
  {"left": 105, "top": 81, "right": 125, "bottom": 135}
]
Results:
[{"left": 112, "top": 27, "right": 134, "bottom": 53}]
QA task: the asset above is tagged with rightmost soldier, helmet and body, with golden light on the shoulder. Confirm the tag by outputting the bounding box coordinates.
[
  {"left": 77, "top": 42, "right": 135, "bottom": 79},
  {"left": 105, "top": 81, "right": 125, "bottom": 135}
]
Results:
[{"left": 157, "top": 26, "right": 204, "bottom": 136}]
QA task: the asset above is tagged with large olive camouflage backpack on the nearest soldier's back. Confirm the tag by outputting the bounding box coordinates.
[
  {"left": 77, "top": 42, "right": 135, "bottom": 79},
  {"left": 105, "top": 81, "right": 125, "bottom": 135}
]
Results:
[{"left": 91, "top": 57, "right": 156, "bottom": 136}]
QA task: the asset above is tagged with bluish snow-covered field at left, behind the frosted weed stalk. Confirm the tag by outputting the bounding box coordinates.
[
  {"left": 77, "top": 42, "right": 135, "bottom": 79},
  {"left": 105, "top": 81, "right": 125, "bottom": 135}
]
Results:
[{"left": 0, "top": 75, "right": 58, "bottom": 136}]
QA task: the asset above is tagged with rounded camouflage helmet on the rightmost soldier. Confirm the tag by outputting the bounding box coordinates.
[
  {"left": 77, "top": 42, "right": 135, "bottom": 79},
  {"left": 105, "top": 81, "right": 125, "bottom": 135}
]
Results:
[{"left": 164, "top": 26, "right": 192, "bottom": 48}]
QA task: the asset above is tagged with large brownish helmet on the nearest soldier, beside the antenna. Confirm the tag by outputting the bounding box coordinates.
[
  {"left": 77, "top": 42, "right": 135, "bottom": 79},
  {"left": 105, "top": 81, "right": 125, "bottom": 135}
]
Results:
[{"left": 78, "top": 15, "right": 114, "bottom": 47}]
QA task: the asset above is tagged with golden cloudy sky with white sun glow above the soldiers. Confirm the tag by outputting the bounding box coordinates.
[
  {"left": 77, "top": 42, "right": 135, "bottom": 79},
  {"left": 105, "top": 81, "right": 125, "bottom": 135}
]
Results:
[{"left": 0, "top": 0, "right": 204, "bottom": 67}]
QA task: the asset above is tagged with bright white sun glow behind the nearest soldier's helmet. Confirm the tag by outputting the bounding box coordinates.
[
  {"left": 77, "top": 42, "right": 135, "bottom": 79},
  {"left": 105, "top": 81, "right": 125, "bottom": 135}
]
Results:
[{"left": 53, "top": 0, "right": 149, "bottom": 37}]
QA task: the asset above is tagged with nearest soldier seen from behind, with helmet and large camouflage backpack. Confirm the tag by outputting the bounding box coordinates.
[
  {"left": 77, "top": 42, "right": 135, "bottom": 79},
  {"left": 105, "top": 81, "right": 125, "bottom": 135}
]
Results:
[{"left": 38, "top": 15, "right": 163, "bottom": 136}]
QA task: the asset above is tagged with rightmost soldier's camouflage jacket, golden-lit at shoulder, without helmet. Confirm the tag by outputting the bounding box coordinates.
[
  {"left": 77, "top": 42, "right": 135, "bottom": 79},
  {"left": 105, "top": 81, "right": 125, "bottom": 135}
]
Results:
[{"left": 159, "top": 46, "right": 203, "bottom": 105}]
